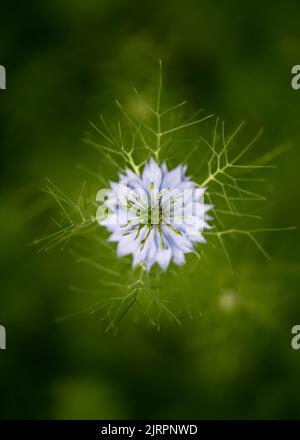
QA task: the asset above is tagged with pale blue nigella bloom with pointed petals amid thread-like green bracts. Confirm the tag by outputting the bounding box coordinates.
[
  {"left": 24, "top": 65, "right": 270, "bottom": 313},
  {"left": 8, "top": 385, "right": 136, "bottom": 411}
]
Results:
[{"left": 97, "top": 159, "right": 211, "bottom": 270}]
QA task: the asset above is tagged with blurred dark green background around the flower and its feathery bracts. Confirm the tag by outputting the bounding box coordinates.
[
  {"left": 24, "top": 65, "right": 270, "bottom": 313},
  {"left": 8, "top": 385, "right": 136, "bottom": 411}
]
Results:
[{"left": 0, "top": 0, "right": 300, "bottom": 419}]
